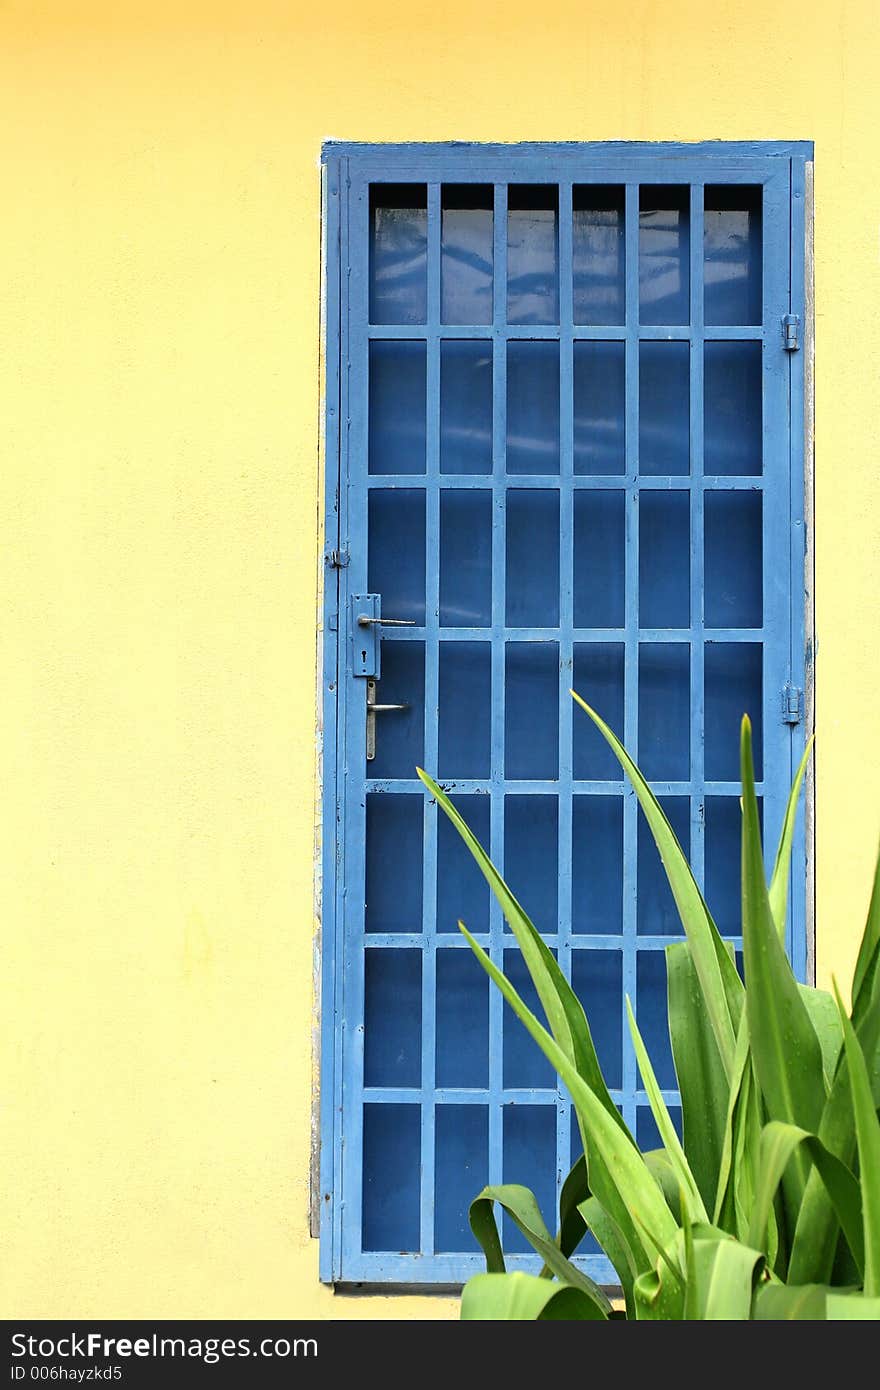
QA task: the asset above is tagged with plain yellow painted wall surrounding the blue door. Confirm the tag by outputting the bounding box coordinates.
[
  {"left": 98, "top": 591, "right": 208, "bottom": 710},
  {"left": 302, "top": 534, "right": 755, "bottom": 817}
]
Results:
[{"left": 0, "top": 0, "right": 880, "bottom": 1318}]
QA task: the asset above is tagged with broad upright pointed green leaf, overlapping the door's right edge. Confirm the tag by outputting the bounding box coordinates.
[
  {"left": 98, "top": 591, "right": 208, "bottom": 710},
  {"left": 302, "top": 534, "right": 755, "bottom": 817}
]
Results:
[{"left": 740, "top": 716, "right": 826, "bottom": 1222}]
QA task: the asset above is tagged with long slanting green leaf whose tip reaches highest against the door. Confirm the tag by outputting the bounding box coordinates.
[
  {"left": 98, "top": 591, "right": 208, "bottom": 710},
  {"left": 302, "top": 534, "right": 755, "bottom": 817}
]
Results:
[{"left": 571, "top": 691, "right": 742, "bottom": 1076}]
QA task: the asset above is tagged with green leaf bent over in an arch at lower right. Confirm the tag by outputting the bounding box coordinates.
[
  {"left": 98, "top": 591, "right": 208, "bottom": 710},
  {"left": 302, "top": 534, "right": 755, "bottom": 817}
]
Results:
[{"left": 749, "top": 1120, "right": 865, "bottom": 1272}]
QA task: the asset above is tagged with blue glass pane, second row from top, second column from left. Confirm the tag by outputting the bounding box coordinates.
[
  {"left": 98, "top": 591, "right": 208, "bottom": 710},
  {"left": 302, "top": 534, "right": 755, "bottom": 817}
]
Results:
[{"left": 441, "top": 339, "right": 492, "bottom": 473}]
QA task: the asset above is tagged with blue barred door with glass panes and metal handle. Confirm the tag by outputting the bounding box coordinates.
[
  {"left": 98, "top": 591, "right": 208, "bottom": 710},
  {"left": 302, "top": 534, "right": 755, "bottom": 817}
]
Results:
[{"left": 320, "top": 145, "right": 809, "bottom": 1284}]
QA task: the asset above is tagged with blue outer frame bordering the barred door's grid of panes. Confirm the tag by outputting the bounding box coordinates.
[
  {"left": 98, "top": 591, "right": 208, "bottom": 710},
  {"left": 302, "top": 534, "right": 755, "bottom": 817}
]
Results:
[{"left": 318, "top": 142, "right": 812, "bottom": 1286}]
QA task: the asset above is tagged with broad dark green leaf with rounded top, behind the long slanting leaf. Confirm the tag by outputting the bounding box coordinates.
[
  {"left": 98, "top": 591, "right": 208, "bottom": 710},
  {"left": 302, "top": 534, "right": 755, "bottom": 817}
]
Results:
[{"left": 666, "top": 941, "right": 735, "bottom": 1211}]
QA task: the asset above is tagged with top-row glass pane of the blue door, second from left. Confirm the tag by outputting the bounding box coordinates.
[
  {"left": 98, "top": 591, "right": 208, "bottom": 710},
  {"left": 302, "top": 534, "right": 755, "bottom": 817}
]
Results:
[{"left": 441, "top": 183, "right": 494, "bottom": 324}]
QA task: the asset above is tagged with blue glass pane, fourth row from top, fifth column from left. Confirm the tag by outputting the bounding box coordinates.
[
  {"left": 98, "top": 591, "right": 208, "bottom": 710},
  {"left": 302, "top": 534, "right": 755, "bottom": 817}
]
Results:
[{"left": 638, "top": 642, "right": 691, "bottom": 781}]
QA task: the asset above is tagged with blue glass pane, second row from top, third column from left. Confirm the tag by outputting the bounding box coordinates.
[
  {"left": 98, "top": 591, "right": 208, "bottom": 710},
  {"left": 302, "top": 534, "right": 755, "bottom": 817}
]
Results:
[{"left": 507, "top": 342, "right": 559, "bottom": 474}]
